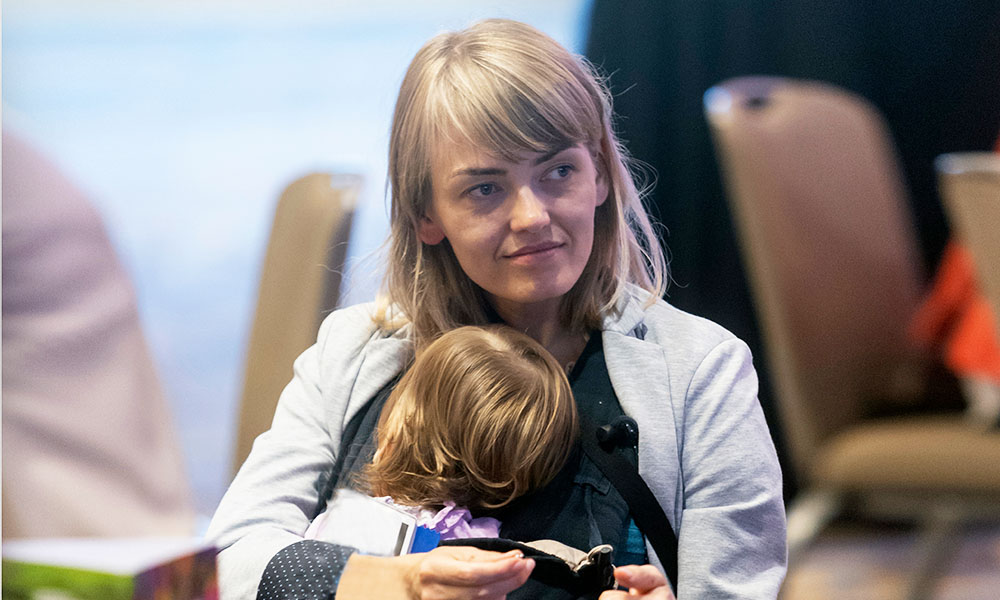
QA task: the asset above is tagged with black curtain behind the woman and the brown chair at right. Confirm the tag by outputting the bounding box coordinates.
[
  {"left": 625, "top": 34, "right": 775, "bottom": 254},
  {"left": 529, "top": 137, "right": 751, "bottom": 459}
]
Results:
[{"left": 586, "top": 0, "right": 1000, "bottom": 498}]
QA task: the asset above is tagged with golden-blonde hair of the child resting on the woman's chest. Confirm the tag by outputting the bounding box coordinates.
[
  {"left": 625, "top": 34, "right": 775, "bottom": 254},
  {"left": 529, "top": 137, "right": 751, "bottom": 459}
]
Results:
[{"left": 362, "top": 326, "right": 577, "bottom": 508}]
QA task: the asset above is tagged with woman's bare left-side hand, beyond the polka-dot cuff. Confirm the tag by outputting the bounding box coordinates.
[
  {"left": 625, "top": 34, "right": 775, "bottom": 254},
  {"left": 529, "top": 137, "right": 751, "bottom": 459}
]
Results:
[{"left": 401, "top": 546, "right": 535, "bottom": 600}]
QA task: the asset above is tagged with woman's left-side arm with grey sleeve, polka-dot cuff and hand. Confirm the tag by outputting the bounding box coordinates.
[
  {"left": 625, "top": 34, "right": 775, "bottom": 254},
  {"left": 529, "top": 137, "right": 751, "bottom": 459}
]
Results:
[{"left": 208, "top": 307, "right": 534, "bottom": 600}]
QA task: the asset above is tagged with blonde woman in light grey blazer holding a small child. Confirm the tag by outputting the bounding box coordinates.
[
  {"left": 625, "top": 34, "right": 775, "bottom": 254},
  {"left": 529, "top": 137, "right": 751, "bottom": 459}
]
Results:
[{"left": 209, "top": 20, "right": 785, "bottom": 599}]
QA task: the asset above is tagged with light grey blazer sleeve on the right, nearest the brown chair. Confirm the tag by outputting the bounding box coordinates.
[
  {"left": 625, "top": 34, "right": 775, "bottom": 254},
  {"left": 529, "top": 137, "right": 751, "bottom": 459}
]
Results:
[{"left": 678, "top": 339, "right": 786, "bottom": 599}]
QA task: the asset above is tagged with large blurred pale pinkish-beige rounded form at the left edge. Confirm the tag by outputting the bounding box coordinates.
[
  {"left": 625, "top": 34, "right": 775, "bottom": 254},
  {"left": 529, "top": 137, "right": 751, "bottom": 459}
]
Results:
[{"left": 3, "top": 131, "right": 195, "bottom": 539}]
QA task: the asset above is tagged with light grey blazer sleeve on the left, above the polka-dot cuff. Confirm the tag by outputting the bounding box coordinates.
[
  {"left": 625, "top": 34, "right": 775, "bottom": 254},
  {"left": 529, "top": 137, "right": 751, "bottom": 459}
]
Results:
[{"left": 206, "top": 310, "right": 371, "bottom": 600}]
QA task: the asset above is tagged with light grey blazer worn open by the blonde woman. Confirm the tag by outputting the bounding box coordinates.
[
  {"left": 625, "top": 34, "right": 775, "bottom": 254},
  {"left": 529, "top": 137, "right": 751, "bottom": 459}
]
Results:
[{"left": 208, "top": 289, "right": 786, "bottom": 600}]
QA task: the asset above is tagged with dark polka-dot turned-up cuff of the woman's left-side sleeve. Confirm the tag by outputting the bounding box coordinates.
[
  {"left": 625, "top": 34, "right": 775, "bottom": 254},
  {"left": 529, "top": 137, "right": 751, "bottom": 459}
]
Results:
[{"left": 257, "top": 540, "right": 355, "bottom": 600}]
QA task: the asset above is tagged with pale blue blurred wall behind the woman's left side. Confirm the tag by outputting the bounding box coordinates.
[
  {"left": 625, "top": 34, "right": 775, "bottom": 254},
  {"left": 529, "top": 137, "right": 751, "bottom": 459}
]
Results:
[{"left": 3, "top": 0, "right": 589, "bottom": 514}]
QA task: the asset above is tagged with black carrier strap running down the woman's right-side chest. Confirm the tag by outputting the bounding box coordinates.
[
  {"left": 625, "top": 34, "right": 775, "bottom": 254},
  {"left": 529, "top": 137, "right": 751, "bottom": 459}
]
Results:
[{"left": 580, "top": 414, "right": 677, "bottom": 594}]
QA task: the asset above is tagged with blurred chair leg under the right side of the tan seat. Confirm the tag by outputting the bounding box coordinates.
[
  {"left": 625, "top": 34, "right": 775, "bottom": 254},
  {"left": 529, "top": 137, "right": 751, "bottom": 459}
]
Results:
[{"left": 904, "top": 506, "right": 963, "bottom": 600}]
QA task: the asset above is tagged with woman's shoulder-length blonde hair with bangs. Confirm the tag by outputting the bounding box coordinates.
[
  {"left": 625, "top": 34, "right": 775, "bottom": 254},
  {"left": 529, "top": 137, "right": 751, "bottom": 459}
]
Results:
[{"left": 376, "top": 19, "right": 666, "bottom": 348}]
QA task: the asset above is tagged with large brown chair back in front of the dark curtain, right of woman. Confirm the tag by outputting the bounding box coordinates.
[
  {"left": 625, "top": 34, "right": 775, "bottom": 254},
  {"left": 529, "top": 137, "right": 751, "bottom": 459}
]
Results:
[{"left": 705, "top": 77, "right": 923, "bottom": 480}]
